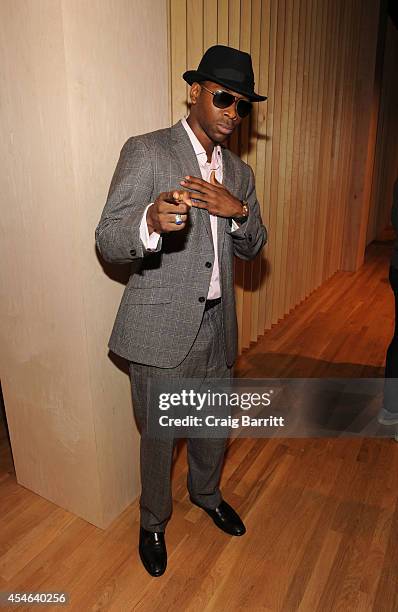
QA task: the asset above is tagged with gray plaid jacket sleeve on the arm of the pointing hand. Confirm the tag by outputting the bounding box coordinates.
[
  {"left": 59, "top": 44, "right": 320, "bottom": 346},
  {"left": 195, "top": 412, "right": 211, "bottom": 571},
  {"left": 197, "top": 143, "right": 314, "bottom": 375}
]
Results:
[{"left": 95, "top": 137, "right": 162, "bottom": 263}]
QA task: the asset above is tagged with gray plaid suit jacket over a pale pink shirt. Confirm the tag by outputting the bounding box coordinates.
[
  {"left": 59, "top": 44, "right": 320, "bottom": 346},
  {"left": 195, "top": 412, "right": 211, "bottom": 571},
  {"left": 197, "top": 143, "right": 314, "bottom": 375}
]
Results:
[{"left": 95, "top": 121, "right": 266, "bottom": 368}]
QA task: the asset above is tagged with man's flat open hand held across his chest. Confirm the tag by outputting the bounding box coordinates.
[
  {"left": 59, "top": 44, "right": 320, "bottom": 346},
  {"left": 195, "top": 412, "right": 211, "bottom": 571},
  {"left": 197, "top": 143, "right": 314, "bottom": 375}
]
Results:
[{"left": 180, "top": 170, "right": 242, "bottom": 217}]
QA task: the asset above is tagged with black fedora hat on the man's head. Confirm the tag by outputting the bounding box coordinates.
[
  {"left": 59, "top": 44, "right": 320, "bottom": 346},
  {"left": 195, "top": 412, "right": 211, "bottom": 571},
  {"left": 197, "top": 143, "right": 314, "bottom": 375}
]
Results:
[{"left": 182, "top": 45, "right": 267, "bottom": 102}]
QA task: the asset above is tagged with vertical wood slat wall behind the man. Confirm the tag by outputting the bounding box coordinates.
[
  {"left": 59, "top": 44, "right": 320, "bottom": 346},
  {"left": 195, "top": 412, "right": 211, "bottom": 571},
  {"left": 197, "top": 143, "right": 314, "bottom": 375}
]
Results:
[{"left": 170, "top": 0, "right": 379, "bottom": 351}]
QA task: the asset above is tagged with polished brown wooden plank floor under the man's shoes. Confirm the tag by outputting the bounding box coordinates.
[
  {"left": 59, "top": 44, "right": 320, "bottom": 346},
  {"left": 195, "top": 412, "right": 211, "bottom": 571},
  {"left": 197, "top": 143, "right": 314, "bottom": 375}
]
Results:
[{"left": 0, "top": 244, "right": 398, "bottom": 612}]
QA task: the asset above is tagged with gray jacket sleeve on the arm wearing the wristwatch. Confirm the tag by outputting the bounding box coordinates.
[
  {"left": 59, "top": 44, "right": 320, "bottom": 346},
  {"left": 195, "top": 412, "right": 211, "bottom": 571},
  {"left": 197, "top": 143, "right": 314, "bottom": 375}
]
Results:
[{"left": 227, "top": 166, "right": 267, "bottom": 260}]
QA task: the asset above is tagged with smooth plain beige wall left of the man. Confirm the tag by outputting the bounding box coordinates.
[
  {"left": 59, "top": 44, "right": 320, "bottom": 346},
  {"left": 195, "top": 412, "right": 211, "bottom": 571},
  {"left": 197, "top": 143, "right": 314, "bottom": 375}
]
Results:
[{"left": 0, "top": 0, "right": 169, "bottom": 526}]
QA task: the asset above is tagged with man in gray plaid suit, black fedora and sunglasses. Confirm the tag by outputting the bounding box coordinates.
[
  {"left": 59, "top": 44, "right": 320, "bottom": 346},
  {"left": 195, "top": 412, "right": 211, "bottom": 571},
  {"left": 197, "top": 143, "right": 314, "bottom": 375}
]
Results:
[{"left": 96, "top": 45, "right": 266, "bottom": 576}]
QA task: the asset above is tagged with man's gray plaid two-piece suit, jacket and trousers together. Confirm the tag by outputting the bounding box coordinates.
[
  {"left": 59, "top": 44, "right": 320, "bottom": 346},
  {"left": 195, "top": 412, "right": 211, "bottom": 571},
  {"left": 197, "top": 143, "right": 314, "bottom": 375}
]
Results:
[{"left": 95, "top": 121, "right": 266, "bottom": 531}]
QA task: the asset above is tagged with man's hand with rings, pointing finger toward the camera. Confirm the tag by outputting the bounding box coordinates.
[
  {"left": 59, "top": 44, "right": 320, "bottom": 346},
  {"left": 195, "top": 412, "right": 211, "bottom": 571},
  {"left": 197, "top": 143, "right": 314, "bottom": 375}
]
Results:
[{"left": 146, "top": 189, "right": 192, "bottom": 234}]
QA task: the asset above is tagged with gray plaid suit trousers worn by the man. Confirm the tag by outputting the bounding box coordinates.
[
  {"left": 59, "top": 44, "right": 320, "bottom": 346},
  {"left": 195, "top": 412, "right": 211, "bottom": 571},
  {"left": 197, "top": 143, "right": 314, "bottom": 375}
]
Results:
[{"left": 130, "top": 304, "right": 232, "bottom": 531}]
